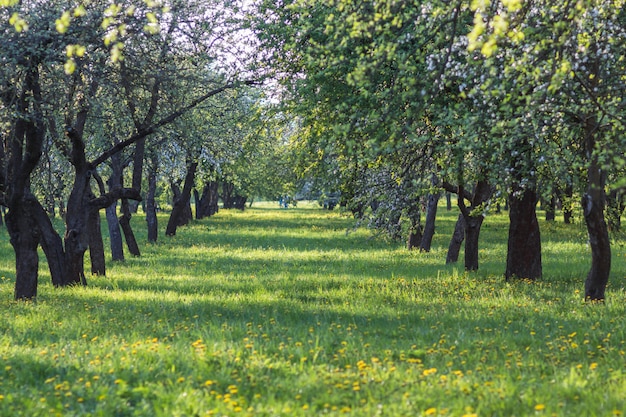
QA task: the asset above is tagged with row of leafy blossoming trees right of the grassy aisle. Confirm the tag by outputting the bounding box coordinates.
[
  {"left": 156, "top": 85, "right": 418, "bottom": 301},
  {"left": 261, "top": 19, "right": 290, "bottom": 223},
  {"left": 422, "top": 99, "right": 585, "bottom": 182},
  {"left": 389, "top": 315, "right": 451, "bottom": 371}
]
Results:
[{"left": 249, "top": 0, "right": 626, "bottom": 300}]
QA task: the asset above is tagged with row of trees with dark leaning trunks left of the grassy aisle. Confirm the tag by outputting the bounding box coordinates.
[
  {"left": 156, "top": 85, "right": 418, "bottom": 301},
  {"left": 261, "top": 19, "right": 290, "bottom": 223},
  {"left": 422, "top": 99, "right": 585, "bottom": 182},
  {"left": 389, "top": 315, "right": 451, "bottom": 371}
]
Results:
[{"left": 0, "top": 0, "right": 292, "bottom": 299}]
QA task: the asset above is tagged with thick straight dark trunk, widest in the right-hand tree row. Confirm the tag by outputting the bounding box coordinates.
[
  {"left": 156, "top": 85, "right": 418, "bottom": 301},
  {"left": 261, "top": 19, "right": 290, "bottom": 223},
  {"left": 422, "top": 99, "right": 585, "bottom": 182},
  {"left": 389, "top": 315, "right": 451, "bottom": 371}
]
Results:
[{"left": 505, "top": 189, "right": 542, "bottom": 280}]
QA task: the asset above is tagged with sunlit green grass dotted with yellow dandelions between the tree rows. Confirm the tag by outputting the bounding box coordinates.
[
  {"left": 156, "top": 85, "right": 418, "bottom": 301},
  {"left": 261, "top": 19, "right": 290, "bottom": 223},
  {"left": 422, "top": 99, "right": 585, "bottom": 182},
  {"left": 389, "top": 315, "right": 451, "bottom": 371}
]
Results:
[{"left": 0, "top": 200, "right": 626, "bottom": 416}]
